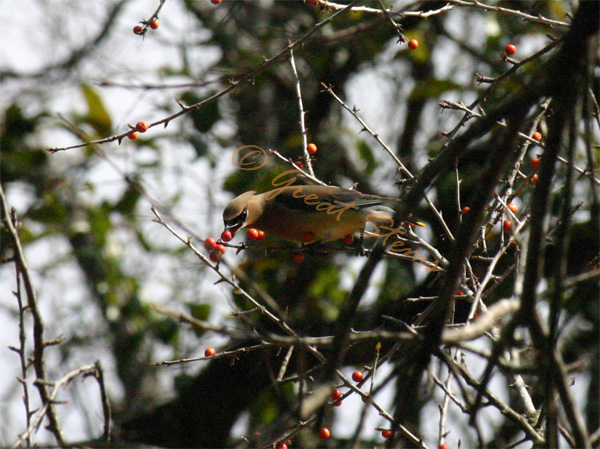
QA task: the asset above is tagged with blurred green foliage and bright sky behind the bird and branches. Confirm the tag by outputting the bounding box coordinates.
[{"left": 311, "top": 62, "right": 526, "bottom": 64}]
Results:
[{"left": 0, "top": 0, "right": 600, "bottom": 447}]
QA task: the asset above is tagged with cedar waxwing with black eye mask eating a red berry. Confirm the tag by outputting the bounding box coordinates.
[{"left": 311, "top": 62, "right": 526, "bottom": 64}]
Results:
[{"left": 223, "top": 172, "right": 420, "bottom": 243}]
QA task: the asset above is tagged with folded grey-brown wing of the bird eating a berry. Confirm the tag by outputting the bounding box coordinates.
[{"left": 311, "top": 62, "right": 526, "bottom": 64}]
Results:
[{"left": 268, "top": 185, "right": 399, "bottom": 212}]
